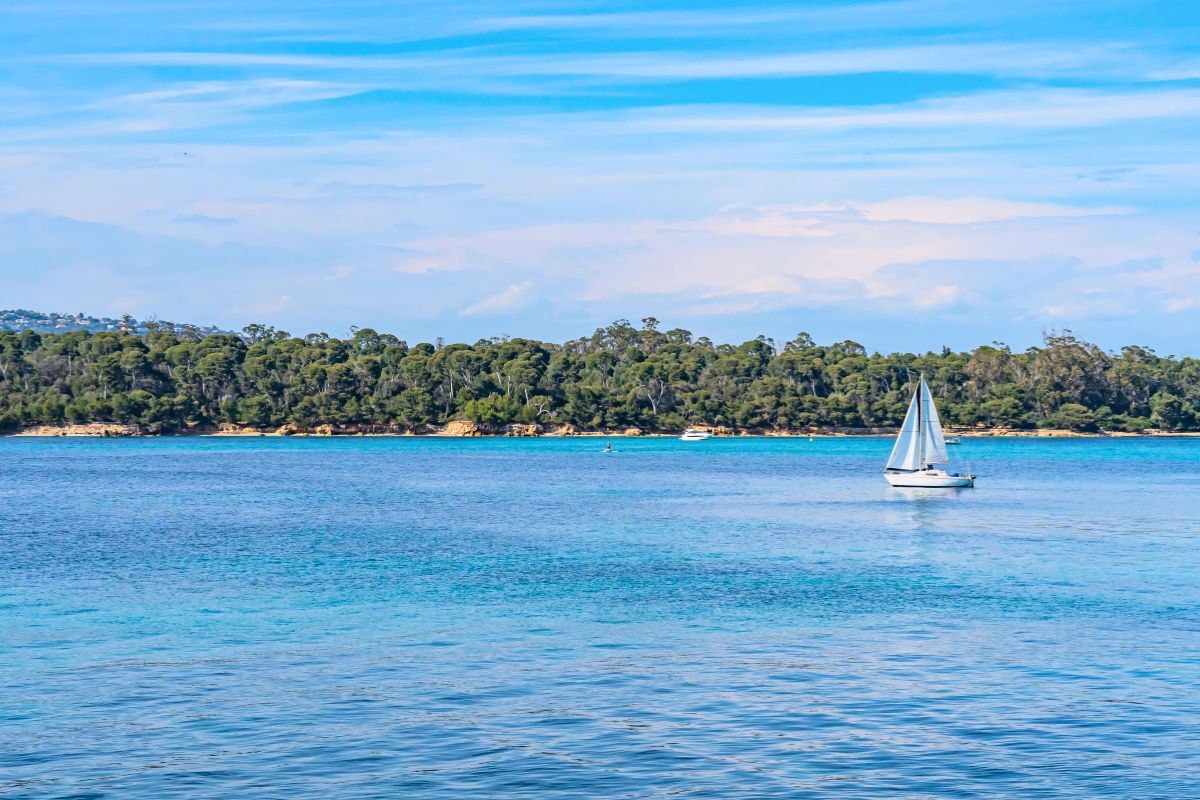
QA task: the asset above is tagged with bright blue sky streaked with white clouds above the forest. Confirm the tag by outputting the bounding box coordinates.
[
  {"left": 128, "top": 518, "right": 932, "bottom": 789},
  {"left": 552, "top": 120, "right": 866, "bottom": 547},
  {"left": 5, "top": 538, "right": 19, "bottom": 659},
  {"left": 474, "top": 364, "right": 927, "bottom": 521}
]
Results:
[{"left": 0, "top": 0, "right": 1200, "bottom": 355}]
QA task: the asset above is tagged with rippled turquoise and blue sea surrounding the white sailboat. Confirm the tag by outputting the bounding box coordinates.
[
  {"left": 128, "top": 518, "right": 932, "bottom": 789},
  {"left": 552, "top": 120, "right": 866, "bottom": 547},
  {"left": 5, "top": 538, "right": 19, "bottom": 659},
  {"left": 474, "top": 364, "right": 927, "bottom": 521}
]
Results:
[{"left": 0, "top": 439, "right": 1200, "bottom": 799}]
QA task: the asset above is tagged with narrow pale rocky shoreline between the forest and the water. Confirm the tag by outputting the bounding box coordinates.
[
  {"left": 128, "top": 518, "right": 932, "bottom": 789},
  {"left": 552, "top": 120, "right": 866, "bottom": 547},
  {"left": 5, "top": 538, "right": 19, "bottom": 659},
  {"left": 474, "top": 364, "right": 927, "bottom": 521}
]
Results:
[{"left": 9, "top": 421, "right": 1200, "bottom": 439}]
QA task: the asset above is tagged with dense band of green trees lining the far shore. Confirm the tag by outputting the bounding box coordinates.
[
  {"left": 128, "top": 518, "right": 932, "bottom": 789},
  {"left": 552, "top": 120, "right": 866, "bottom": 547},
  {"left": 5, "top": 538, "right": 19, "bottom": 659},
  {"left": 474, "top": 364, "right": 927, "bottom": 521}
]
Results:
[{"left": 0, "top": 318, "right": 1200, "bottom": 433}]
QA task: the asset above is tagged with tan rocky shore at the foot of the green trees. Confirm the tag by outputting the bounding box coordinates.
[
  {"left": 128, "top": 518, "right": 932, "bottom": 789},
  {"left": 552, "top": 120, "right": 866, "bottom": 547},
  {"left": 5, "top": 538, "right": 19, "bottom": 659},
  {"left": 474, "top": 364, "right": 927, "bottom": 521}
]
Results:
[{"left": 11, "top": 420, "right": 1200, "bottom": 439}]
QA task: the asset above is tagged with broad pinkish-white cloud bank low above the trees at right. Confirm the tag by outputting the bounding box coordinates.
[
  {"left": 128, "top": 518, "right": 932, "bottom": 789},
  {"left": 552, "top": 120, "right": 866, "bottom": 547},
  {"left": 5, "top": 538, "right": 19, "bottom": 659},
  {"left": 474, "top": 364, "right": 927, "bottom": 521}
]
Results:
[{"left": 396, "top": 198, "right": 1200, "bottom": 326}]
